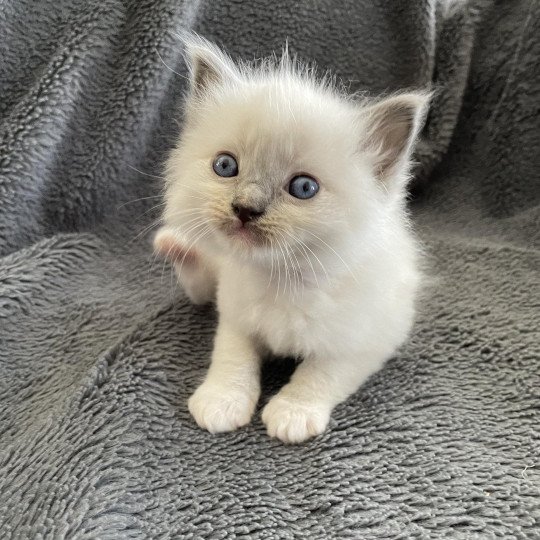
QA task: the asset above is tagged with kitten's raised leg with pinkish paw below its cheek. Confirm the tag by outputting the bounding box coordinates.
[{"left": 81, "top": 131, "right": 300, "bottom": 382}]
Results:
[{"left": 154, "top": 227, "right": 217, "bottom": 304}]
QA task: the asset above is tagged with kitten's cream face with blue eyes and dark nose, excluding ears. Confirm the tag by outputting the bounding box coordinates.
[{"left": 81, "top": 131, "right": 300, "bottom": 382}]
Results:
[{"left": 167, "top": 86, "right": 372, "bottom": 260}]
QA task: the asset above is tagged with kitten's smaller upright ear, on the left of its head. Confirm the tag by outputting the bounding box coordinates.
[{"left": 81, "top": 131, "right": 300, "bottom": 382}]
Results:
[{"left": 184, "top": 36, "right": 238, "bottom": 96}]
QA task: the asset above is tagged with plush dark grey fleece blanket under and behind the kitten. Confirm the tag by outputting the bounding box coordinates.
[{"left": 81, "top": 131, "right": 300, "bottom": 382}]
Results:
[{"left": 0, "top": 0, "right": 540, "bottom": 539}]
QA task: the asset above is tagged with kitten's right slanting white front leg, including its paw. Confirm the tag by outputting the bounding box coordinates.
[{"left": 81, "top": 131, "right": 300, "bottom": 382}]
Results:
[{"left": 262, "top": 352, "right": 388, "bottom": 443}]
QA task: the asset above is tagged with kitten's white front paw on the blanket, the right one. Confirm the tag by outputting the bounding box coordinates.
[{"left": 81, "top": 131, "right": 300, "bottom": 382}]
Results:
[{"left": 262, "top": 394, "right": 331, "bottom": 444}]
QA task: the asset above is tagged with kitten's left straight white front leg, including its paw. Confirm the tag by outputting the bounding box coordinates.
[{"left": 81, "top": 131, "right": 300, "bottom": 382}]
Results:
[{"left": 188, "top": 320, "right": 261, "bottom": 433}]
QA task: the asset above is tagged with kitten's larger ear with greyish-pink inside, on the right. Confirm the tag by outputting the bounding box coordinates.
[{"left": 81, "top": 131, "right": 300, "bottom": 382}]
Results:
[{"left": 360, "top": 92, "right": 429, "bottom": 189}]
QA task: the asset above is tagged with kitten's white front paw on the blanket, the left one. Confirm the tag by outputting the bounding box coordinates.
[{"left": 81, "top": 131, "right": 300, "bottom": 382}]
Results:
[{"left": 188, "top": 383, "right": 259, "bottom": 433}]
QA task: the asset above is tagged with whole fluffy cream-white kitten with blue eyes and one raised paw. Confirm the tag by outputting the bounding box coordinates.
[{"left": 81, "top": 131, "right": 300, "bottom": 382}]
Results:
[{"left": 155, "top": 38, "right": 428, "bottom": 443}]
